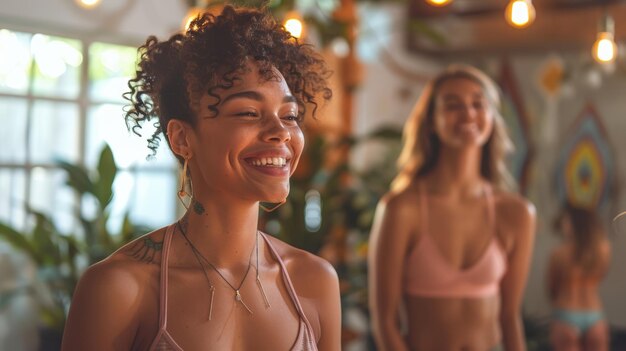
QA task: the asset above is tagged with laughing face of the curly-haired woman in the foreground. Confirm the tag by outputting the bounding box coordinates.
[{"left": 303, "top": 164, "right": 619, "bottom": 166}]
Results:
[{"left": 185, "top": 62, "right": 304, "bottom": 202}]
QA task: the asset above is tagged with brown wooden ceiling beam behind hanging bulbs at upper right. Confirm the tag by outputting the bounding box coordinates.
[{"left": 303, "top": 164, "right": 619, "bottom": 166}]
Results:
[{"left": 408, "top": 1, "right": 626, "bottom": 56}]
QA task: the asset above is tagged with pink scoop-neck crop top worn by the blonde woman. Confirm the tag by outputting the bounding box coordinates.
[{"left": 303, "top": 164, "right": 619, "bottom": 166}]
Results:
[{"left": 404, "top": 186, "right": 507, "bottom": 298}]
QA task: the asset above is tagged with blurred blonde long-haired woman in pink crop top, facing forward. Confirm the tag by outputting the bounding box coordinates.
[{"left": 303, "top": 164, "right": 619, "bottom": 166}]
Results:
[{"left": 369, "top": 65, "right": 535, "bottom": 351}]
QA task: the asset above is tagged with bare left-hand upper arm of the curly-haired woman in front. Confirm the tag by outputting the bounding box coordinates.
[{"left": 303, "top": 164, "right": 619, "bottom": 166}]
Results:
[{"left": 62, "top": 263, "right": 139, "bottom": 351}]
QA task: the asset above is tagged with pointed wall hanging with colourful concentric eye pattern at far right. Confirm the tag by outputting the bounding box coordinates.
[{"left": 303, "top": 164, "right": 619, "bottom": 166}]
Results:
[{"left": 556, "top": 104, "right": 616, "bottom": 208}]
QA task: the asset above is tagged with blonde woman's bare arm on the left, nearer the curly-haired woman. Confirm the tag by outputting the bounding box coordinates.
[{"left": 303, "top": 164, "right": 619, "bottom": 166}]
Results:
[{"left": 368, "top": 195, "right": 411, "bottom": 351}]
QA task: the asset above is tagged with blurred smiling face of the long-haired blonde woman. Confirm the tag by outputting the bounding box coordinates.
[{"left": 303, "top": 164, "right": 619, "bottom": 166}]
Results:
[{"left": 434, "top": 78, "right": 494, "bottom": 148}]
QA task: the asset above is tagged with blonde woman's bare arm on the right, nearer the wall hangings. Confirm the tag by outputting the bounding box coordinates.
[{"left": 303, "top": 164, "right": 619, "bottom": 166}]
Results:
[{"left": 500, "top": 198, "right": 535, "bottom": 351}]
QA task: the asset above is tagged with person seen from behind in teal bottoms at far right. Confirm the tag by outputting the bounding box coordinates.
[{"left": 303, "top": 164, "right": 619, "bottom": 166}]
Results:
[{"left": 547, "top": 202, "right": 611, "bottom": 351}]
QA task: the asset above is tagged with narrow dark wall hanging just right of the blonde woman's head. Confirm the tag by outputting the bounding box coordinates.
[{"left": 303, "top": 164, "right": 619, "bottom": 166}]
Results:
[{"left": 500, "top": 60, "right": 534, "bottom": 194}]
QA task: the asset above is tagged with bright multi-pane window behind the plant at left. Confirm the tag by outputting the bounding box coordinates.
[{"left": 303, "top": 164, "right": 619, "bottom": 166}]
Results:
[{"left": 0, "top": 29, "right": 177, "bottom": 233}]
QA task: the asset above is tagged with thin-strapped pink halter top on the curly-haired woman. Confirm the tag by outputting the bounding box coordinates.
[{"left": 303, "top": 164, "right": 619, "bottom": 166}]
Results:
[{"left": 150, "top": 225, "right": 317, "bottom": 351}]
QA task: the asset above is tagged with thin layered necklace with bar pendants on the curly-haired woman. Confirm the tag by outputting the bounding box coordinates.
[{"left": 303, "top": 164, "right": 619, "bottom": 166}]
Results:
[{"left": 179, "top": 225, "right": 270, "bottom": 319}]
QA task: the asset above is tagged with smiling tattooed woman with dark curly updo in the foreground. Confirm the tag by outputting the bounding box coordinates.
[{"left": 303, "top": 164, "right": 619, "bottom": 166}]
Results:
[{"left": 63, "top": 6, "right": 341, "bottom": 350}]
